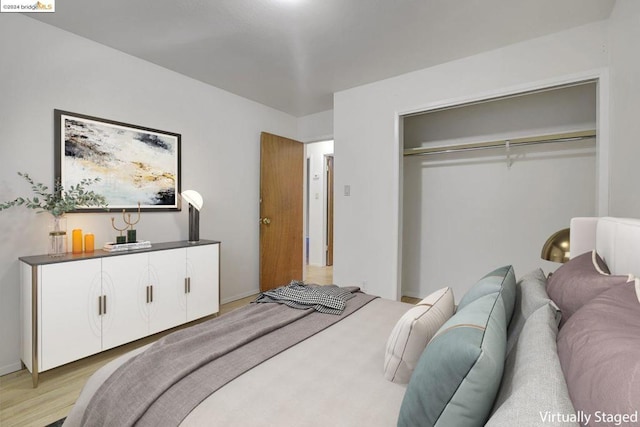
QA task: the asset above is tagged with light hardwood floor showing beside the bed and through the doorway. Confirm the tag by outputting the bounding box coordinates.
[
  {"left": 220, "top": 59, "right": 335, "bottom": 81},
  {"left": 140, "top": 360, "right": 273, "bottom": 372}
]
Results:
[{"left": 0, "top": 266, "right": 417, "bottom": 427}]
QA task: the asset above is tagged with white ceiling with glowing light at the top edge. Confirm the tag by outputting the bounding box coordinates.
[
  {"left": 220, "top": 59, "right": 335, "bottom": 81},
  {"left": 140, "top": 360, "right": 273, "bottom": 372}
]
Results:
[{"left": 28, "top": 0, "right": 615, "bottom": 117}]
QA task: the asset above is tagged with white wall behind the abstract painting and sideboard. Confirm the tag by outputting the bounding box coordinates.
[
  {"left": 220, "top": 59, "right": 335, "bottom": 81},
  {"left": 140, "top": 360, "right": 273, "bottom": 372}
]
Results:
[{"left": 0, "top": 14, "right": 297, "bottom": 374}]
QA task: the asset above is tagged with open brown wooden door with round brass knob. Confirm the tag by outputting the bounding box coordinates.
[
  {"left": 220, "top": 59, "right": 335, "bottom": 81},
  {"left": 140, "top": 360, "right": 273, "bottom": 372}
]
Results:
[{"left": 260, "top": 132, "right": 304, "bottom": 292}]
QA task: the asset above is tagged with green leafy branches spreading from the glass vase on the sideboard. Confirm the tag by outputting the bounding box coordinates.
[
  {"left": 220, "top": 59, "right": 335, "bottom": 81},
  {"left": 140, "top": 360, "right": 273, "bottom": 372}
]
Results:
[{"left": 0, "top": 172, "right": 107, "bottom": 217}]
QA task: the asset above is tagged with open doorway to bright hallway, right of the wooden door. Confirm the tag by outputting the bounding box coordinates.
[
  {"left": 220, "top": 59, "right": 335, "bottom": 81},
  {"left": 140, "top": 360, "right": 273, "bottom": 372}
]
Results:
[{"left": 304, "top": 140, "right": 333, "bottom": 284}]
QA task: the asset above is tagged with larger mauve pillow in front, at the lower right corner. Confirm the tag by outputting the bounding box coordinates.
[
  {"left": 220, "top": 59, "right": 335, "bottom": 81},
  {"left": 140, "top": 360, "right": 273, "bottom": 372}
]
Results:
[{"left": 558, "top": 283, "right": 640, "bottom": 425}]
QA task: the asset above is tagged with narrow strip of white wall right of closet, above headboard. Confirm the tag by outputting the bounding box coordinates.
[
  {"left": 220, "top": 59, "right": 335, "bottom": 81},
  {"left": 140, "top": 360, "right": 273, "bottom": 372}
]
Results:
[{"left": 609, "top": 0, "right": 640, "bottom": 218}]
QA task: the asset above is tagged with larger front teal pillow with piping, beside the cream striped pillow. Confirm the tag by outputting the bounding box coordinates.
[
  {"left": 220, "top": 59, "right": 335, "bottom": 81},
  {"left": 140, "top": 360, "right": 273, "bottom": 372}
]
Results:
[{"left": 398, "top": 292, "right": 515, "bottom": 427}]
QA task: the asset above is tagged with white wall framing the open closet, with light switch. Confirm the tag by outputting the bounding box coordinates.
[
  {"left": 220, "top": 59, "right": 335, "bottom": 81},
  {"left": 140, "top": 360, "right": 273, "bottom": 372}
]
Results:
[{"left": 334, "top": 22, "right": 608, "bottom": 298}]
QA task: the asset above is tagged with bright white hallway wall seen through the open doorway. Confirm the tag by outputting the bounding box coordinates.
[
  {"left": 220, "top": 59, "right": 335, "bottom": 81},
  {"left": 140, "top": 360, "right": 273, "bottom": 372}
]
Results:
[{"left": 305, "top": 141, "right": 333, "bottom": 266}]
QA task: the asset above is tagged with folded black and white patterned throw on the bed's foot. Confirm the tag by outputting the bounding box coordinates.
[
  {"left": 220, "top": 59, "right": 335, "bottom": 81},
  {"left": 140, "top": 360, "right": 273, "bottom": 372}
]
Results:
[{"left": 254, "top": 280, "right": 360, "bottom": 314}]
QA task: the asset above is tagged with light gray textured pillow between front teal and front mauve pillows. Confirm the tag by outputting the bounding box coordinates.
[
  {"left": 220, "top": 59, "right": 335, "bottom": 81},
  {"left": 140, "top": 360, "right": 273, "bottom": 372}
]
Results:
[{"left": 487, "top": 299, "right": 578, "bottom": 427}]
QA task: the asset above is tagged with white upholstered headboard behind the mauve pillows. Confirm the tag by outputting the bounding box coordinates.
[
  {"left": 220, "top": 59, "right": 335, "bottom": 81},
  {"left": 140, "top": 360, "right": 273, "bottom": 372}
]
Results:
[{"left": 570, "top": 217, "right": 640, "bottom": 277}]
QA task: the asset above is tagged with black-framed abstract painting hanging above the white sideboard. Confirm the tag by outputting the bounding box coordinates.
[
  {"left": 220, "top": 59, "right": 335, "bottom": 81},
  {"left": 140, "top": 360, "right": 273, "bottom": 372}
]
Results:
[{"left": 54, "top": 109, "right": 182, "bottom": 212}]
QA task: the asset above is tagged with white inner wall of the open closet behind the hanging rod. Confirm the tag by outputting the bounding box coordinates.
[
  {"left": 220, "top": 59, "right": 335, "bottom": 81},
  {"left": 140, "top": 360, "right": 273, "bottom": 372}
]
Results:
[{"left": 402, "top": 82, "right": 597, "bottom": 300}]
